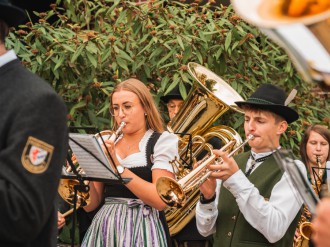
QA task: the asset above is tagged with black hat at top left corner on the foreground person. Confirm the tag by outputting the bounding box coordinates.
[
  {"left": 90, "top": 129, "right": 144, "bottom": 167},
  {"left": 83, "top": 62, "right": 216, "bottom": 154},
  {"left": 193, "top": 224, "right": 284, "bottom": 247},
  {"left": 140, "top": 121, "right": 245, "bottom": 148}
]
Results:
[{"left": 0, "top": 0, "right": 26, "bottom": 27}]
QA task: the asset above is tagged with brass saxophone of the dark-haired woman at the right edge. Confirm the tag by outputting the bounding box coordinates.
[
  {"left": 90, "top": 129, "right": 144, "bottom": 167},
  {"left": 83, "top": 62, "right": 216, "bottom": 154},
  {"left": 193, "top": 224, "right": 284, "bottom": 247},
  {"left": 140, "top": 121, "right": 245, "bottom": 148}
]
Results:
[{"left": 294, "top": 155, "right": 324, "bottom": 247}]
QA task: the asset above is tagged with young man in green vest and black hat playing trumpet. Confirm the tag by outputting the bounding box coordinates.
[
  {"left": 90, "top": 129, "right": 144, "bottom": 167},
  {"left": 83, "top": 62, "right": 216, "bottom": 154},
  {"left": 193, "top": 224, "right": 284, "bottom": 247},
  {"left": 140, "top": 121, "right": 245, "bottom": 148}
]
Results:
[{"left": 196, "top": 84, "right": 307, "bottom": 247}]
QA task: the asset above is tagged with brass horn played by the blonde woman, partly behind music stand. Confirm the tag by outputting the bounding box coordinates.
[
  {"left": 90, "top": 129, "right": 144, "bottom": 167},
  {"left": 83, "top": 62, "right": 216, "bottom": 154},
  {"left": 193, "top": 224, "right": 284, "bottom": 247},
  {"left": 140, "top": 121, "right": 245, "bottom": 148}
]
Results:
[{"left": 58, "top": 122, "right": 125, "bottom": 217}]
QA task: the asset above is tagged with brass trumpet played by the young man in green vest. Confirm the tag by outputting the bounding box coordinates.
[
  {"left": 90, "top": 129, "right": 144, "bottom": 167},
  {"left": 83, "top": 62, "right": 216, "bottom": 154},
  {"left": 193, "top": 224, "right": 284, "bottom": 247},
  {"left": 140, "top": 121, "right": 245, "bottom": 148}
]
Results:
[{"left": 156, "top": 134, "right": 254, "bottom": 208}]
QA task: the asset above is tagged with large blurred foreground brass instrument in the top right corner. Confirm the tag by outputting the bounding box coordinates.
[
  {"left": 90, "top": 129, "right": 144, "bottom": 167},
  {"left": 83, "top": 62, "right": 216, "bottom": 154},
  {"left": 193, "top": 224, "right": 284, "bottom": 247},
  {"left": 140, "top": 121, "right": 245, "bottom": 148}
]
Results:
[{"left": 231, "top": 0, "right": 330, "bottom": 90}]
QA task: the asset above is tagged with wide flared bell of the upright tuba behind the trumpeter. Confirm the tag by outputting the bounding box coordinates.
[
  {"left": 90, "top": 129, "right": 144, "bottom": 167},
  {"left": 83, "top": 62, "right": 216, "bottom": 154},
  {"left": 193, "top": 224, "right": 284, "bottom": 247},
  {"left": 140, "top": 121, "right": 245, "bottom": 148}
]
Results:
[{"left": 167, "top": 62, "right": 244, "bottom": 138}]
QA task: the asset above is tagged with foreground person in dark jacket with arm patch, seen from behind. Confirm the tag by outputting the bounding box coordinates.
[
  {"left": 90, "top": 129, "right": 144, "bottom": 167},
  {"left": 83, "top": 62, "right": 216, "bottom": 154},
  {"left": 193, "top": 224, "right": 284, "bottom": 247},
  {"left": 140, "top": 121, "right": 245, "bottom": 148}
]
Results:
[{"left": 0, "top": 0, "right": 68, "bottom": 247}]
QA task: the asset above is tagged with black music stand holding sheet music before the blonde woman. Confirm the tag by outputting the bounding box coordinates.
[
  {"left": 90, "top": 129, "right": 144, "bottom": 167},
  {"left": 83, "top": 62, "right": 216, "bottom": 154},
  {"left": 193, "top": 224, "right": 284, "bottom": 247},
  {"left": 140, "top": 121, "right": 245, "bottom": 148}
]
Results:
[{"left": 62, "top": 127, "right": 131, "bottom": 247}]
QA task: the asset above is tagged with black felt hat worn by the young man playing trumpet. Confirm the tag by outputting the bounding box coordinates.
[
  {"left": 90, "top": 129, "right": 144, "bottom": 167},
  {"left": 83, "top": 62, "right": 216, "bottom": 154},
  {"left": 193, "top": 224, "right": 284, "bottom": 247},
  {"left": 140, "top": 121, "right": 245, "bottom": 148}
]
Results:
[{"left": 235, "top": 84, "right": 299, "bottom": 123}]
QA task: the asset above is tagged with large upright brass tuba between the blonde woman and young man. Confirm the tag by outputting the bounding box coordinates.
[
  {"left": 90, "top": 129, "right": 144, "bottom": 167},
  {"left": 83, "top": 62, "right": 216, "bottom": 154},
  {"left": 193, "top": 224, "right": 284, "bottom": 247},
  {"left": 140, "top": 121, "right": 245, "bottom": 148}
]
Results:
[{"left": 162, "top": 63, "right": 243, "bottom": 236}]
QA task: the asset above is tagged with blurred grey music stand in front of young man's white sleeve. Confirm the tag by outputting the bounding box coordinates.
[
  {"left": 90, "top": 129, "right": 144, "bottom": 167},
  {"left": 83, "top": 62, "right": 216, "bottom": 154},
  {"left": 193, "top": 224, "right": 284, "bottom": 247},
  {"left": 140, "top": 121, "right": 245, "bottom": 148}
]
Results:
[{"left": 273, "top": 149, "right": 319, "bottom": 214}]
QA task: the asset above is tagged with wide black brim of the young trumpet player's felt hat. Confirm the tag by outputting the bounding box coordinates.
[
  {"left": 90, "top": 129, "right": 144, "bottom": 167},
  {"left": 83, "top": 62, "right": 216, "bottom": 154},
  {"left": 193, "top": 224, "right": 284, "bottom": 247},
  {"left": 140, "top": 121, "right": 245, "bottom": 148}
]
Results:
[{"left": 235, "top": 101, "right": 299, "bottom": 123}]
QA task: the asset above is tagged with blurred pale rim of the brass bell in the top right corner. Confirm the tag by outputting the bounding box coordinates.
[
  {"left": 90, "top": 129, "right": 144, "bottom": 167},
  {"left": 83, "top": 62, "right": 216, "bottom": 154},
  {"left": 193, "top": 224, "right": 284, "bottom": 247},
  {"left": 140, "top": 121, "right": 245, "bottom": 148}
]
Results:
[{"left": 232, "top": 0, "right": 330, "bottom": 28}]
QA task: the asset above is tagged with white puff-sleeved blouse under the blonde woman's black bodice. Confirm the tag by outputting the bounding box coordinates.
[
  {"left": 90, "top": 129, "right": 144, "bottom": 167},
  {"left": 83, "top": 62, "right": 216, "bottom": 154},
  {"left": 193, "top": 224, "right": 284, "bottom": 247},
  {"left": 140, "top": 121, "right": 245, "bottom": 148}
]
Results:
[{"left": 117, "top": 129, "right": 179, "bottom": 172}]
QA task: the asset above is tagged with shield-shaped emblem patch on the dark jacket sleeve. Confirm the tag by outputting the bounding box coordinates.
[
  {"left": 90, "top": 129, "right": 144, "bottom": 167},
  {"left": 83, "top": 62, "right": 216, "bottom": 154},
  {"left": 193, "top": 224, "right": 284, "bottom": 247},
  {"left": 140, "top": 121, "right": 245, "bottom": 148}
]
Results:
[{"left": 21, "top": 136, "right": 54, "bottom": 173}]
